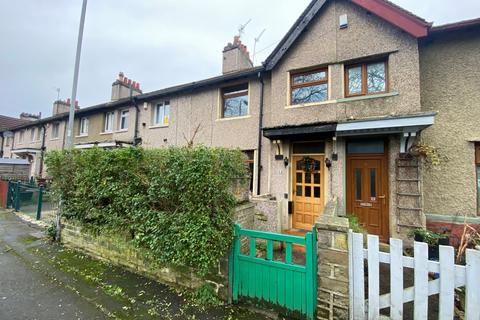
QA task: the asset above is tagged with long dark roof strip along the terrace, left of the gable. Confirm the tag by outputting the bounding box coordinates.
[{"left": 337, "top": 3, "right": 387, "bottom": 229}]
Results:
[{"left": 0, "top": 66, "right": 265, "bottom": 132}]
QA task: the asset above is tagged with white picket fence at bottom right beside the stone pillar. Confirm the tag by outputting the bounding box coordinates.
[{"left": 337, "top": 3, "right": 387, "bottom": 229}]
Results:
[{"left": 348, "top": 231, "right": 480, "bottom": 320}]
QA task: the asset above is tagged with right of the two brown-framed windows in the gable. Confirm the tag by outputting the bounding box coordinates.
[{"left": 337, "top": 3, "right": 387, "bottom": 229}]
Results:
[{"left": 345, "top": 61, "right": 387, "bottom": 97}]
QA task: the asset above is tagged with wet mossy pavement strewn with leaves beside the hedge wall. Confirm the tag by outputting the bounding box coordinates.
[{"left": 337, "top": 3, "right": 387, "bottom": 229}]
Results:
[{"left": 0, "top": 209, "right": 272, "bottom": 320}]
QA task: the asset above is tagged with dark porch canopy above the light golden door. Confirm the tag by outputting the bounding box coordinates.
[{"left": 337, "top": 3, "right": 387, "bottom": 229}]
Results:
[{"left": 263, "top": 122, "right": 337, "bottom": 140}]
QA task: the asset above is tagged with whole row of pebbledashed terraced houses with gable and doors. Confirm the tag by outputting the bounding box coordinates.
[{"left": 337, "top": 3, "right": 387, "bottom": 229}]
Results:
[{"left": 4, "top": 0, "right": 480, "bottom": 241}]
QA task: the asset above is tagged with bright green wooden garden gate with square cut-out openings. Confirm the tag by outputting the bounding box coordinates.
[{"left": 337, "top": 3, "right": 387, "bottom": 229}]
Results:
[{"left": 230, "top": 225, "right": 317, "bottom": 319}]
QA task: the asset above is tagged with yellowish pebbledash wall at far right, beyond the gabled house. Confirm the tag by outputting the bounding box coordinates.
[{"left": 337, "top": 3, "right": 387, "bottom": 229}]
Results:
[{"left": 420, "top": 27, "right": 480, "bottom": 237}]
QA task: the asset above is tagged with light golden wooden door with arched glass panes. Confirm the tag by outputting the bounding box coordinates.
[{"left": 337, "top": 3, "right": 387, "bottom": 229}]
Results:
[{"left": 292, "top": 155, "right": 324, "bottom": 230}]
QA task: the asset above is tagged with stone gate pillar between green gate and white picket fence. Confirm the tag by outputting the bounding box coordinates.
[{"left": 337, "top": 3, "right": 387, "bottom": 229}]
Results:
[{"left": 316, "top": 199, "right": 349, "bottom": 320}]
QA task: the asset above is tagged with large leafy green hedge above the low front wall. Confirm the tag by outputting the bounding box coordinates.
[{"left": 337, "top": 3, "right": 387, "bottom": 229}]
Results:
[{"left": 46, "top": 146, "right": 246, "bottom": 275}]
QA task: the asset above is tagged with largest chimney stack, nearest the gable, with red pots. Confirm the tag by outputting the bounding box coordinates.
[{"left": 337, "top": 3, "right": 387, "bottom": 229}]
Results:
[{"left": 222, "top": 36, "right": 253, "bottom": 74}]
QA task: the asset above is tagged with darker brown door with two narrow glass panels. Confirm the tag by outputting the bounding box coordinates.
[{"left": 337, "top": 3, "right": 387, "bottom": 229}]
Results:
[{"left": 347, "top": 155, "right": 389, "bottom": 241}]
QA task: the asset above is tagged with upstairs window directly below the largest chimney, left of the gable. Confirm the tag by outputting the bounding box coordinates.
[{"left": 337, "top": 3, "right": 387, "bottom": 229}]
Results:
[{"left": 222, "top": 83, "right": 248, "bottom": 118}]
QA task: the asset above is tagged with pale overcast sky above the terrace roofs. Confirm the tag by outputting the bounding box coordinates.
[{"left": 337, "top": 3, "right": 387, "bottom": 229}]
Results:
[{"left": 0, "top": 0, "right": 480, "bottom": 117}]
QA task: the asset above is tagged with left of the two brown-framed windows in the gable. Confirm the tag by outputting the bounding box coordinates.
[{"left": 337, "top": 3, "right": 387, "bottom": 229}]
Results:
[{"left": 291, "top": 68, "right": 328, "bottom": 104}]
